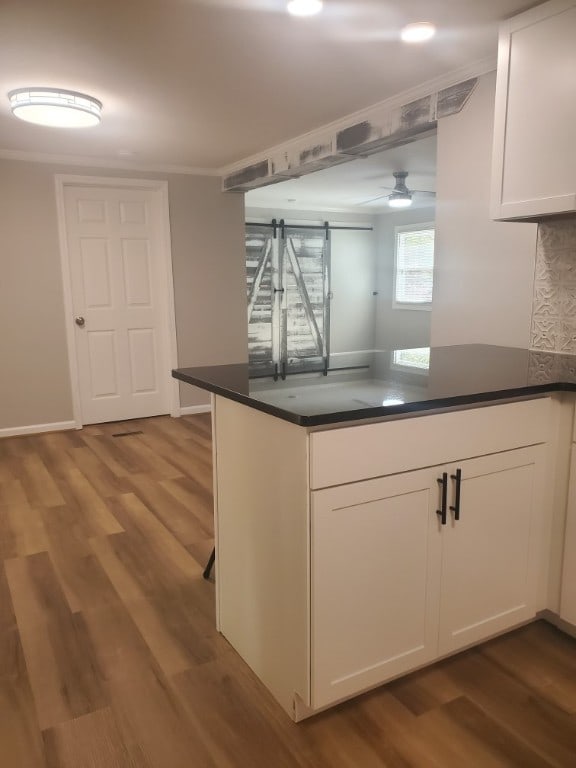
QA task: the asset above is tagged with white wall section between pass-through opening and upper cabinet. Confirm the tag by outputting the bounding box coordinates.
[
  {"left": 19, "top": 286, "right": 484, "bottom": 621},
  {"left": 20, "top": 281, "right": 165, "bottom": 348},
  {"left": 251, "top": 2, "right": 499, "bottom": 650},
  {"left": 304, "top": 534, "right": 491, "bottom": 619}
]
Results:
[{"left": 431, "top": 73, "right": 536, "bottom": 347}]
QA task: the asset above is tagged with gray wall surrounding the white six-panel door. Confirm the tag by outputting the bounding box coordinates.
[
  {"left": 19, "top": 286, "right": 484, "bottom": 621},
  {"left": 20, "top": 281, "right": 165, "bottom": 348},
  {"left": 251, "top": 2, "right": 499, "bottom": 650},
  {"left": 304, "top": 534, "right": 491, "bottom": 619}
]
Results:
[{"left": 0, "top": 160, "right": 247, "bottom": 429}]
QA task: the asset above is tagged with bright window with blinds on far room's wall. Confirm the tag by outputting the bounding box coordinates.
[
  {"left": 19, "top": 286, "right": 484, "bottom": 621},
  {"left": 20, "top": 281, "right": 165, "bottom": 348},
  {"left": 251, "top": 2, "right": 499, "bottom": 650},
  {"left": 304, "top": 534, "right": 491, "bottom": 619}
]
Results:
[{"left": 394, "top": 224, "right": 434, "bottom": 309}]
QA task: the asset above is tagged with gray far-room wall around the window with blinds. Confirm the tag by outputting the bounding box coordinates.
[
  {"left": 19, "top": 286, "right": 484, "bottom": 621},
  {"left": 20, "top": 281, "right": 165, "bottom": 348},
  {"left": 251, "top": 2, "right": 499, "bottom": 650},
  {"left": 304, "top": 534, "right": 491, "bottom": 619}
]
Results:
[{"left": 376, "top": 206, "right": 435, "bottom": 349}]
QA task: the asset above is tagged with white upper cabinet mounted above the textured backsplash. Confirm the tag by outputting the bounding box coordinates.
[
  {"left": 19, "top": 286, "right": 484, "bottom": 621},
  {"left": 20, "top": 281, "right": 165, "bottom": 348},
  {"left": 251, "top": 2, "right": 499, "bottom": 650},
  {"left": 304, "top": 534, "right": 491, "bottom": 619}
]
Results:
[{"left": 491, "top": 0, "right": 576, "bottom": 220}]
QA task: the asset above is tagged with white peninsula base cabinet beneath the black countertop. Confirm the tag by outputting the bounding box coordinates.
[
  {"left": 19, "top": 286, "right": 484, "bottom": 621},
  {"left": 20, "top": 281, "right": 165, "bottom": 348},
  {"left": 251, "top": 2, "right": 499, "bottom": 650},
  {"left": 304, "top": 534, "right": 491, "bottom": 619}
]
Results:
[{"left": 213, "top": 397, "right": 557, "bottom": 720}]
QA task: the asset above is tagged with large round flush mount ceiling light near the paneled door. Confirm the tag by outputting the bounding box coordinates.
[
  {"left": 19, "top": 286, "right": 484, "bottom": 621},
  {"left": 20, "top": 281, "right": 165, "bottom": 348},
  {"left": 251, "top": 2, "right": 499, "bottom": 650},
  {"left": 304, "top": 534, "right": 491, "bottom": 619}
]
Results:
[{"left": 8, "top": 88, "right": 102, "bottom": 128}]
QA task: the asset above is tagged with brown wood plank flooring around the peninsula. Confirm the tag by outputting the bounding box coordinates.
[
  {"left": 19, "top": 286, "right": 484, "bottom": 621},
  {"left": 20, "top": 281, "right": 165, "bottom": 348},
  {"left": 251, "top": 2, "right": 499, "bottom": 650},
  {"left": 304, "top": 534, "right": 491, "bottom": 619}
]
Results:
[{"left": 0, "top": 415, "right": 576, "bottom": 768}]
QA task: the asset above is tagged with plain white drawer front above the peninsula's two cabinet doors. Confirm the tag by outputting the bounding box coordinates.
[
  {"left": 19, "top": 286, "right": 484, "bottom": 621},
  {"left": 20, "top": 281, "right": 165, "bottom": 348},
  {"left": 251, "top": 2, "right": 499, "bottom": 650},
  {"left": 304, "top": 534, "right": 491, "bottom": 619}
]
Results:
[{"left": 310, "top": 398, "right": 551, "bottom": 489}]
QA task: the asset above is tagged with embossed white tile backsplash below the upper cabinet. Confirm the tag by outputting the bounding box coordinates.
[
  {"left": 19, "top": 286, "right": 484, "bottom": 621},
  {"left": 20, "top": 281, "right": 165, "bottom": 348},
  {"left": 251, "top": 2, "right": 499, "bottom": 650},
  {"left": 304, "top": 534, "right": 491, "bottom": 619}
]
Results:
[{"left": 530, "top": 219, "right": 576, "bottom": 354}]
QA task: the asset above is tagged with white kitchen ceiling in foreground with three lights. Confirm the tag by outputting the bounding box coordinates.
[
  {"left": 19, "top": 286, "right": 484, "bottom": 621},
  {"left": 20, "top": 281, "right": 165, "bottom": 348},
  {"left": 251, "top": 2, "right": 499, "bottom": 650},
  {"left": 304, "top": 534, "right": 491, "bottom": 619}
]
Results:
[{"left": 0, "top": 0, "right": 534, "bottom": 170}]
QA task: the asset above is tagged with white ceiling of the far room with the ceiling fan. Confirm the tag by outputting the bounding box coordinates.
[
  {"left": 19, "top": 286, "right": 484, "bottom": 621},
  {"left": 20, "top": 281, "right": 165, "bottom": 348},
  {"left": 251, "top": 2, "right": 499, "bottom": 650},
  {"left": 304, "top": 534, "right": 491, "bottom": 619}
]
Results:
[{"left": 246, "top": 136, "right": 436, "bottom": 214}]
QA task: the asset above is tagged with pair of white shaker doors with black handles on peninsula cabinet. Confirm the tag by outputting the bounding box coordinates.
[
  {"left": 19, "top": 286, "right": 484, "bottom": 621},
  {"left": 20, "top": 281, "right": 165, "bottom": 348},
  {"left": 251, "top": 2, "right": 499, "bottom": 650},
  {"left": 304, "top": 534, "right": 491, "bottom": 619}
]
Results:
[{"left": 311, "top": 446, "right": 544, "bottom": 708}]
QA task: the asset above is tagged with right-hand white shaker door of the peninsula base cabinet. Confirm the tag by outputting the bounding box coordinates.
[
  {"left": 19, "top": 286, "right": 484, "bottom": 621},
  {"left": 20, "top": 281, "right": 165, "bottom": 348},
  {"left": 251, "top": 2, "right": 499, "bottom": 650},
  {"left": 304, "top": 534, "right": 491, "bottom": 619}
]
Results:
[{"left": 439, "top": 446, "right": 544, "bottom": 655}]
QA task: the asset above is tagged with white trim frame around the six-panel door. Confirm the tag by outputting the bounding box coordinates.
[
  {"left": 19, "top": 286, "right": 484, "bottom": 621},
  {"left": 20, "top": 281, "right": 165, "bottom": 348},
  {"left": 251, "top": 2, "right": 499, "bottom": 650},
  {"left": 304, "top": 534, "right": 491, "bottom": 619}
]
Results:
[{"left": 54, "top": 173, "right": 181, "bottom": 429}]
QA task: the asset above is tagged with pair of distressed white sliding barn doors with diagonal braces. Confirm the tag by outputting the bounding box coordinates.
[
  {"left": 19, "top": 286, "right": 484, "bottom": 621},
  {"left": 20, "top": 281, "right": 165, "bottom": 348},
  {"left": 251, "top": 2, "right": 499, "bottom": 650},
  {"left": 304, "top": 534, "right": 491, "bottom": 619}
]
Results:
[{"left": 246, "top": 224, "right": 330, "bottom": 376}]
